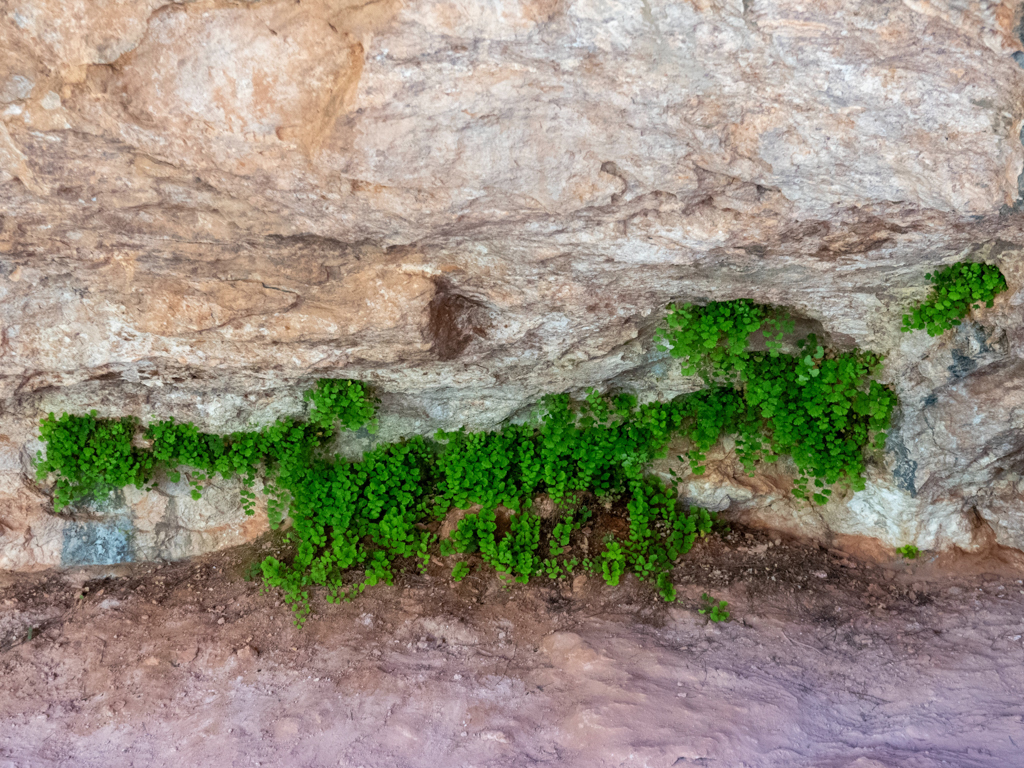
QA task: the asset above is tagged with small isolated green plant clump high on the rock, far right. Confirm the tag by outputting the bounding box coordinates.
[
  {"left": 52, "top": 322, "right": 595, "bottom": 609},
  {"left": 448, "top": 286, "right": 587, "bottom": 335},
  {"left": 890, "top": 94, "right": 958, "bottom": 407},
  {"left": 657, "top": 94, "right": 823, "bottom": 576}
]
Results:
[{"left": 902, "top": 261, "right": 1007, "bottom": 336}]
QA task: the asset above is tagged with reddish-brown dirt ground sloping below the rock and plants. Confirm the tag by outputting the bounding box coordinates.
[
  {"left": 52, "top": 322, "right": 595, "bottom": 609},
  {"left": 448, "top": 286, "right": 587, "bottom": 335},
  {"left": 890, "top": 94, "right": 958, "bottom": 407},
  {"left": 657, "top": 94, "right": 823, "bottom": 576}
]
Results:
[{"left": 0, "top": 530, "right": 1024, "bottom": 768}]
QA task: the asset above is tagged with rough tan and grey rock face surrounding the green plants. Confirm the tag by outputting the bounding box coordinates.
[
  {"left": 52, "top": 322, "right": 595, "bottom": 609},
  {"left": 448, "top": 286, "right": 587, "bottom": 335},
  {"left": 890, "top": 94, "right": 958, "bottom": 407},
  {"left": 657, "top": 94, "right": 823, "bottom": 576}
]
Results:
[{"left": 0, "top": 0, "right": 1024, "bottom": 568}]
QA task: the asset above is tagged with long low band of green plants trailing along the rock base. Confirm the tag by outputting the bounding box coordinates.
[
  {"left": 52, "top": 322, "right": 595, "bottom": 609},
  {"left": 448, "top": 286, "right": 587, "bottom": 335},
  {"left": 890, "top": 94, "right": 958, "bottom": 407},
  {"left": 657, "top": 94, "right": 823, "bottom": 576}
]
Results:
[{"left": 38, "top": 380, "right": 713, "bottom": 624}]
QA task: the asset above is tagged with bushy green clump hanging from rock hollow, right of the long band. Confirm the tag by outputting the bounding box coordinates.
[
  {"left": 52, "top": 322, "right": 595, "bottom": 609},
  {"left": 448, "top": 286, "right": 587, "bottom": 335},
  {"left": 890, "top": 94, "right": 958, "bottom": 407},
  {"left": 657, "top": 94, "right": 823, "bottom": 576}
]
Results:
[{"left": 659, "top": 299, "right": 896, "bottom": 504}]
